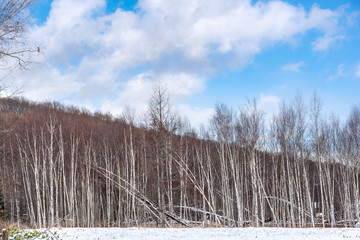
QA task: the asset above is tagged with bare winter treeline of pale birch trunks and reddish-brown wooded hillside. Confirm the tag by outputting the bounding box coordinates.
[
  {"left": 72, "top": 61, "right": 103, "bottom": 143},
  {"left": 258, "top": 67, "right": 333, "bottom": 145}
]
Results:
[{"left": 0, "top": 85, "right": 360, "bottom": 227}]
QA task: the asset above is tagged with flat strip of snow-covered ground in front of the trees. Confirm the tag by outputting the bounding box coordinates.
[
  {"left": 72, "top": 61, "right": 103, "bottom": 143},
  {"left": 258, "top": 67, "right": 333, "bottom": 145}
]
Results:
[{"left": 46, "top": 228, "right": 360, "bottom": 240}]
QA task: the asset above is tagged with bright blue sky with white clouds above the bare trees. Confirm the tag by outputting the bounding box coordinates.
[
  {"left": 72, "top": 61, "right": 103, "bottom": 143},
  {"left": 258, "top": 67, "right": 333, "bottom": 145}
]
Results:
[{"left": 1, "top": 0, "right": 360, "bottom": 126}]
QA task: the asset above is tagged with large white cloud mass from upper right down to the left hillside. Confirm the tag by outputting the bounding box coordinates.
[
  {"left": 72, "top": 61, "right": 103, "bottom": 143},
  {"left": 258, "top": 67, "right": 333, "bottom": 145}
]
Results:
[{"left": 6, "top": 0, "right": 348, "bottom": 123}]
